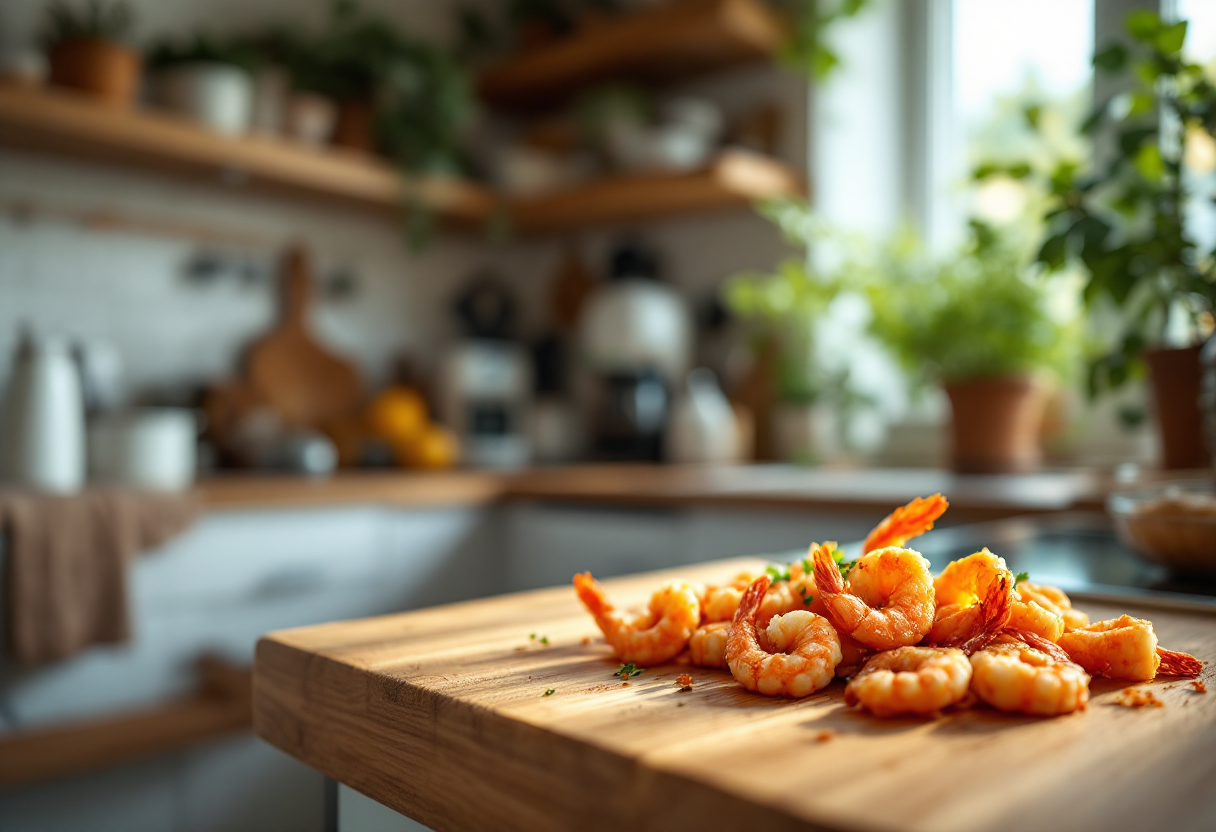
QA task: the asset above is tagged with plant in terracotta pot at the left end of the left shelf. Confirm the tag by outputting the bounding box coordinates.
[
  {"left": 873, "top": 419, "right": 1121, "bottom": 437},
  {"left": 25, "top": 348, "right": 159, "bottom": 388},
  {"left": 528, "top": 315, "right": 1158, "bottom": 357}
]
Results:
[{"left": 43, "top": 0, "right": 140, "bottom": 109}]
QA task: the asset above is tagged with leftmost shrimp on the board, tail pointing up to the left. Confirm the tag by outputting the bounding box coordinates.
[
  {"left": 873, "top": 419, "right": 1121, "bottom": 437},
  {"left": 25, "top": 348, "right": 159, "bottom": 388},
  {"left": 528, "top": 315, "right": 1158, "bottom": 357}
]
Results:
[{"left": 574, "top": 572, "right": 700, "bottom": 667}]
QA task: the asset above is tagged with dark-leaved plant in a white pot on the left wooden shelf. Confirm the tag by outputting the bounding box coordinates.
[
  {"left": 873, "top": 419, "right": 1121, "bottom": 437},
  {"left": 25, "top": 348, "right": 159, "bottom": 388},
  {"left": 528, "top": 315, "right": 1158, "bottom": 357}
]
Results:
[{"left": 147, "top": 34, "right": 253, "bottom": 135}]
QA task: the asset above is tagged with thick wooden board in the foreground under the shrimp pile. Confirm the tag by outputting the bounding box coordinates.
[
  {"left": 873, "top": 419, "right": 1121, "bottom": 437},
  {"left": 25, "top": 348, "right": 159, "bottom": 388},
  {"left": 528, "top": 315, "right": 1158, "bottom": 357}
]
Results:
[{"left": 253, "top": 560, "right": 1216, "bottom": 832}]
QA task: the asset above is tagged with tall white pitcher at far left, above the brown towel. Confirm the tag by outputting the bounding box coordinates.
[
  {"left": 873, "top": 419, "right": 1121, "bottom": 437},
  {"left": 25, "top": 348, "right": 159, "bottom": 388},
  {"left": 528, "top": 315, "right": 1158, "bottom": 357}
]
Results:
[{"left": 0, "top": 333, "right": 85, "bottom": 494}]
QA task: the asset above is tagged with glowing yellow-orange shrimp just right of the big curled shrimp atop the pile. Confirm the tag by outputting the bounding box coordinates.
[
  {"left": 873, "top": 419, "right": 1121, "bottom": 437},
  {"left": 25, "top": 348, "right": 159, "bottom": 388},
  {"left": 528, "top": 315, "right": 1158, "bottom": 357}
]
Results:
[{"left": 925, "top": 549, "right": 1013, "bottom": 653}]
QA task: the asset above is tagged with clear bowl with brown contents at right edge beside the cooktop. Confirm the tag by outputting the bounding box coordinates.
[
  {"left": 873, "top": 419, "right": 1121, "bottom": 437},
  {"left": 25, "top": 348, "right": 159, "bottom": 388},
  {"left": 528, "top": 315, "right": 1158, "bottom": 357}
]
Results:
[{"left": 1107, "top": 479, "right": 1216, "bottom": 574}]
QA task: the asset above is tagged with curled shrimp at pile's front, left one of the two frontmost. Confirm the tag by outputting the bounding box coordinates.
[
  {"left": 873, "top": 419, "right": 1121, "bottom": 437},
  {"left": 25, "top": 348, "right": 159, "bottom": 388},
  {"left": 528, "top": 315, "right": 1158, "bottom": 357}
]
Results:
[{"left": 844, "top": 647, "right": 972, "bottom": 716}]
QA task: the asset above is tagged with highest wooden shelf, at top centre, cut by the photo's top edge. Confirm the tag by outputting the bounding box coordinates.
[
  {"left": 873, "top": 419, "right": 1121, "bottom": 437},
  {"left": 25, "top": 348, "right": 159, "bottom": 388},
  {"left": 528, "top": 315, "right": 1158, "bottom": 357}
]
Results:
[{"left": 478, "top": 0, "right": 786, "bottom": 109}]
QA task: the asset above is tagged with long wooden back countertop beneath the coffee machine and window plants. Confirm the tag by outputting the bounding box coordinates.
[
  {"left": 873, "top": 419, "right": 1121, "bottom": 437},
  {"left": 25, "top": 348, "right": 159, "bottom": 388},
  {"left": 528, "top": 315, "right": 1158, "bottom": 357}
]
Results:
[{"left": 199, "top": 465, "right": 1110, "bottom": 519}]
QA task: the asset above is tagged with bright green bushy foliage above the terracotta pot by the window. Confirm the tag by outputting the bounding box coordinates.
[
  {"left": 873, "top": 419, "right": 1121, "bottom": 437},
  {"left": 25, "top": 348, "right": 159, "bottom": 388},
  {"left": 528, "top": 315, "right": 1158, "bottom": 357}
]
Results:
[{"left": 867, "top": 221, "right": 1076, "bottom": 383}]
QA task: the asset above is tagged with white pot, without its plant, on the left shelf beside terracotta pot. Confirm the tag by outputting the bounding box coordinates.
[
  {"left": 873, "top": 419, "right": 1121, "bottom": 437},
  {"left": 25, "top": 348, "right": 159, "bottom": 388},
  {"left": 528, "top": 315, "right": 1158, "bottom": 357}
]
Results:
[{"left": 156, "top": 62, "right": 253, "bottom": 135}]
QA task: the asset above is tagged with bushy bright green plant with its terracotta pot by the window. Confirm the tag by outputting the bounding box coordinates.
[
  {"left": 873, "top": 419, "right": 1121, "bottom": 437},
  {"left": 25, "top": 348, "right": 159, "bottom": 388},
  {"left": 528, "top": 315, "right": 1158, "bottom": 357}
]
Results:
[{"left": 867, "top": 221, "right": 1075, "bottom": 472}]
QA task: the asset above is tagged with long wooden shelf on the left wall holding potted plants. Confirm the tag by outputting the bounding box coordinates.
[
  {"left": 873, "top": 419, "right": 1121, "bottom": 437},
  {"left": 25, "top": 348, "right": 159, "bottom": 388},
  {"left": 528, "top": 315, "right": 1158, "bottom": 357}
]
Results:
[{"left": 0, "top": 86, "right": 494, "bottom": 221}]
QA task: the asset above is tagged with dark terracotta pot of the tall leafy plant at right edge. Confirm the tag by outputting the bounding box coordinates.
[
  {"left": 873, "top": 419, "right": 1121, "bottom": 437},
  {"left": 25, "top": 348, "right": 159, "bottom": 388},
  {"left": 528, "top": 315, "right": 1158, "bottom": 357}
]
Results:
[{"left": 1144, "top": 347, "right": 1211, "bottom": 468}]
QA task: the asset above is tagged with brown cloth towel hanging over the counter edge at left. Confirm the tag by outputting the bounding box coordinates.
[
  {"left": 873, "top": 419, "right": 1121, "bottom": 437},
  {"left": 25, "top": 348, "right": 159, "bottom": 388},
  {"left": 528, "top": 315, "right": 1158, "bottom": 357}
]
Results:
[{"left": 0, "top": 488, "right": 201, "bottom": 663}]
